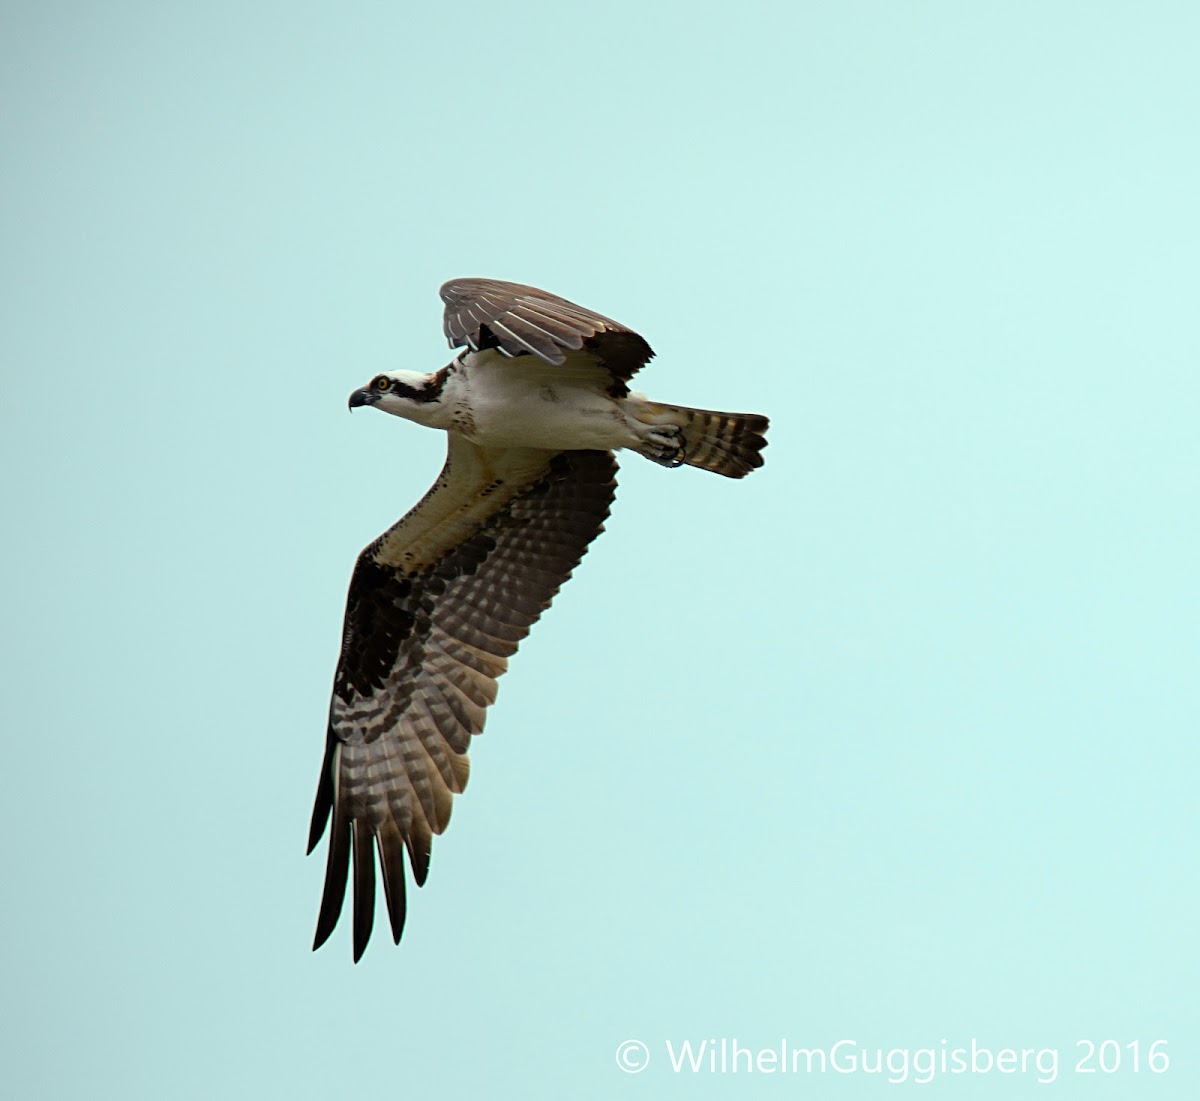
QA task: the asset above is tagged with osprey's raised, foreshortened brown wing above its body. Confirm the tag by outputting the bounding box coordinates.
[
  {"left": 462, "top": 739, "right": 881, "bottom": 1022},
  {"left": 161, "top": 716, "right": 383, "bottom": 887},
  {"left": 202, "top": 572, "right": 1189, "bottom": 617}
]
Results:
[{"left": 440, "top": 279, "right": 654, "bottom": 397}]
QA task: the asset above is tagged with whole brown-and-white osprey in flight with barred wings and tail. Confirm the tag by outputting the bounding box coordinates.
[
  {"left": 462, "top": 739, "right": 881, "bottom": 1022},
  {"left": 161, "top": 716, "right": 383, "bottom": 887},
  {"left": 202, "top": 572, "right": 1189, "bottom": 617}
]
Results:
[{"left": 308, "top": 279, "right": 767, "bottom": 962}]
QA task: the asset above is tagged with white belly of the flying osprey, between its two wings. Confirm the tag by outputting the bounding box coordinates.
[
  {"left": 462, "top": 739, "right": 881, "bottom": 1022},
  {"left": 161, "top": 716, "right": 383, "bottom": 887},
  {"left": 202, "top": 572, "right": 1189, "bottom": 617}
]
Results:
[{"left": 466, "top": 383, "right": 637, "bottom": 451}]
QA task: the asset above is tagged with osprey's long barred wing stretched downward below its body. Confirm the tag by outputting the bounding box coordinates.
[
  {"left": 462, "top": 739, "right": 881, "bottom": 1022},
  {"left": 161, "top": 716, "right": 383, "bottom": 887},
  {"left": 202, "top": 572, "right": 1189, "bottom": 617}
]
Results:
[{"left": 308, "top": 433, "right": 617, "bottom": 961}]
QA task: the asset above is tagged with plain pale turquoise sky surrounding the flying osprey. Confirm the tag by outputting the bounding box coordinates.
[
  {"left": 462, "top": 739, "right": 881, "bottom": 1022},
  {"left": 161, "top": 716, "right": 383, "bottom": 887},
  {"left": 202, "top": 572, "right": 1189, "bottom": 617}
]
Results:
[{"left": 0, "top": 2, "right": 1200, "bottom": 1099}]
